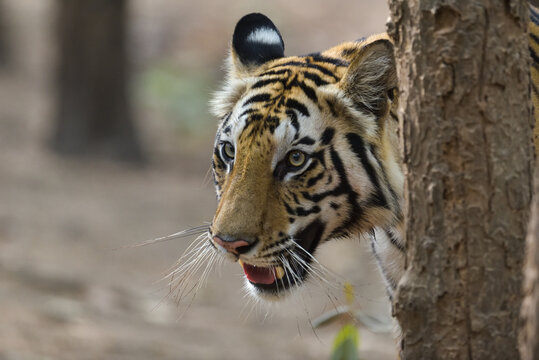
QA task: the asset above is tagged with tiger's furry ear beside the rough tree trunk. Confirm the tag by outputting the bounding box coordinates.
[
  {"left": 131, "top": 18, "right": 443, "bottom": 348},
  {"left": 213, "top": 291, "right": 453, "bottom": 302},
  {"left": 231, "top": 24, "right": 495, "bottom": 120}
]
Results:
[{"left": 340, "top": 37, "right": 397, "bottom": 118}]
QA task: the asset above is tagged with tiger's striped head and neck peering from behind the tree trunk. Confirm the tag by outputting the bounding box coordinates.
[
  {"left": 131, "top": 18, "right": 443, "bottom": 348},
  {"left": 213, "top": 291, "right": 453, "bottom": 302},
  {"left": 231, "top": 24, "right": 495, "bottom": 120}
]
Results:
[{"left": 209, "top": 13, "right": 405, "bottom": 300}]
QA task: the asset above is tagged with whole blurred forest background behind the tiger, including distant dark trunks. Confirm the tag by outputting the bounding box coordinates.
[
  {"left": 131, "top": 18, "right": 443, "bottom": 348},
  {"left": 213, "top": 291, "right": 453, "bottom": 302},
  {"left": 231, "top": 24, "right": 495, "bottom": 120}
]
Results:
[{"left": 0, "top": 0, "right": 396, "bottom": 360}]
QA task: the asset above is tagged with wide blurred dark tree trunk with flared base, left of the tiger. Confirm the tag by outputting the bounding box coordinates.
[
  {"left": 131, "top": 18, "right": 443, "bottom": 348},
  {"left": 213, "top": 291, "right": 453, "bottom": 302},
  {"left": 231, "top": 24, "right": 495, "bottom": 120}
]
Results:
[{"left": 53, "top": 0, "right": 142, "bottom": 161}]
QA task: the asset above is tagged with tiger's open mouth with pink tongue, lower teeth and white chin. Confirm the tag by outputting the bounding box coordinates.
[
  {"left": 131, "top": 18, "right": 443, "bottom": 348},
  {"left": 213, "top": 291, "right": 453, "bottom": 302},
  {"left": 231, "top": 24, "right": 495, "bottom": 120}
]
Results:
[{"left": 238, "top": 221, "right": 325, "bottom": 295}]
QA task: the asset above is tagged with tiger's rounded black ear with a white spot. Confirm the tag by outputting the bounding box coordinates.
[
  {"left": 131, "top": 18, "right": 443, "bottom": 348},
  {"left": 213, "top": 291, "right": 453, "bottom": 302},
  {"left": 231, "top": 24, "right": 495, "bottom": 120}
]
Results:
[{"left": 232, "top": 13, "right": 284, "bottom": 67}]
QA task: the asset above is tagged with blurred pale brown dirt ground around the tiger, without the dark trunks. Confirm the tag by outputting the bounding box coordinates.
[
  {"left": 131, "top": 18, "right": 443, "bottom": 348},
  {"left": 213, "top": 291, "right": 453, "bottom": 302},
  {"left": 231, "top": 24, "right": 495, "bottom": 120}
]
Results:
[{"left": 0, "top": 0, "right": 396, "bottom": 360}]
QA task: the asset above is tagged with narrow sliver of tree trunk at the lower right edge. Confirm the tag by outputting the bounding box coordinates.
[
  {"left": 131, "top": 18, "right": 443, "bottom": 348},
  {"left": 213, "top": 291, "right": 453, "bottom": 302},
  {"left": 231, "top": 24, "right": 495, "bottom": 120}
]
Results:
[{"left": 520, "top": 166, "right": 539, "bottom": 360}]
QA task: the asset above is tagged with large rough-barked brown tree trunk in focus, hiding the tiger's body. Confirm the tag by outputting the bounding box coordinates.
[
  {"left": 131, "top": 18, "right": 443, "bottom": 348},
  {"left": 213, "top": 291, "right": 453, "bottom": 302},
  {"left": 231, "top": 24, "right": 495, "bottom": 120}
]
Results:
[{"left": 388, "top": 0, "right": 532, "bottom": 360}]
